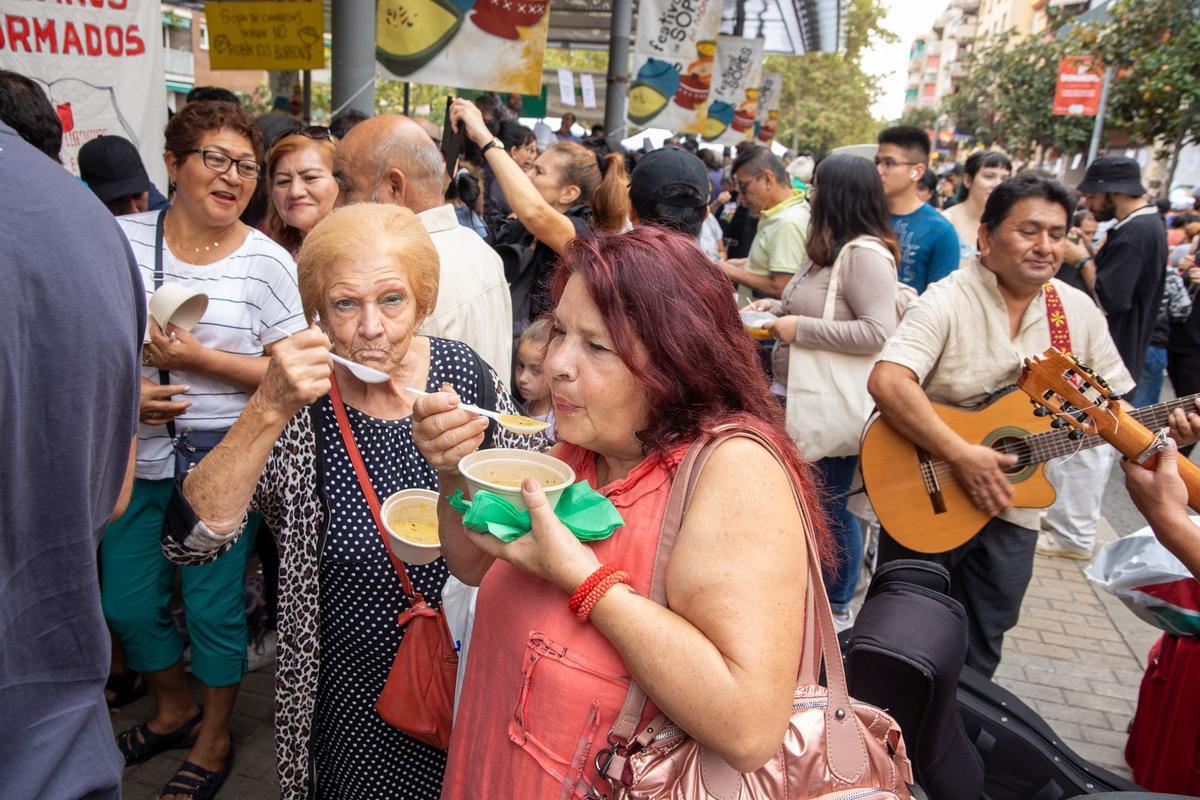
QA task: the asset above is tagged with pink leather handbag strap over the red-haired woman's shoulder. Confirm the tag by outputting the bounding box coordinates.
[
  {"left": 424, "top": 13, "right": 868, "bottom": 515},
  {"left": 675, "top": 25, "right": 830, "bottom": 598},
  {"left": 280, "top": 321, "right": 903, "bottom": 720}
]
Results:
[{"left": 608, "top": 425, "right": 868, "bottom": 781}]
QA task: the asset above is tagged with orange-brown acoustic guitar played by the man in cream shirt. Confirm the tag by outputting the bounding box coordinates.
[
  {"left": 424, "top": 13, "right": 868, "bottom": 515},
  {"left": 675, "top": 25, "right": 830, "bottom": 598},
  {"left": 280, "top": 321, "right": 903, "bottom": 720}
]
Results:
[{"left": 859, "top": 352, "right": 1200, "bottom": 553}]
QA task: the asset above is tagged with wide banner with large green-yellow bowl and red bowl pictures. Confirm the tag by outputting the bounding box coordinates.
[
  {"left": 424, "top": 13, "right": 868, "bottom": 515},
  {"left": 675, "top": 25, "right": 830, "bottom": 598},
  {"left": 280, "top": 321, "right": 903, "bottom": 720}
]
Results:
[{"left": 376, "top": 0, "right": 550, "bottom": 95}]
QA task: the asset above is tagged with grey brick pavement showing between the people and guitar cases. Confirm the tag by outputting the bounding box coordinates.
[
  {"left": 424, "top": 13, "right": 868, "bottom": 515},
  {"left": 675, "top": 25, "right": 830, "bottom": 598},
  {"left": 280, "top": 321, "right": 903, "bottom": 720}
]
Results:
[{"left": 113, "top": 519, "right": 1157, "bottom": 800}]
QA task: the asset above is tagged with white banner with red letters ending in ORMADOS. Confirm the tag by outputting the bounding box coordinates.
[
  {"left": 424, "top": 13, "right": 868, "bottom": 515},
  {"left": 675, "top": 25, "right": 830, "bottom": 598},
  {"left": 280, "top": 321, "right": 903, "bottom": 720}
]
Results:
[{"left": 0, "top": 0, "right": 167, "bottom": 188}]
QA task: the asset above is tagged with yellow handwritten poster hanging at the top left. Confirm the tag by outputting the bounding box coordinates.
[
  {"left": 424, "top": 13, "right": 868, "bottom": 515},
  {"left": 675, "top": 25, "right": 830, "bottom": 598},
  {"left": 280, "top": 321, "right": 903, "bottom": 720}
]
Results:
[{"left": 204, "top": 0, "right": 325, "bottom": 70}]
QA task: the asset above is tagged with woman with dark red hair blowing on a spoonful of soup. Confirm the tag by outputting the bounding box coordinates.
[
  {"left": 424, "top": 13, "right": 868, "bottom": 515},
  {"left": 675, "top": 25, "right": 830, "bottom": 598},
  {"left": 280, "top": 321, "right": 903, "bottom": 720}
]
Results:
[{"left": 413, "top": 227, "right": 823, "bottom": 798}]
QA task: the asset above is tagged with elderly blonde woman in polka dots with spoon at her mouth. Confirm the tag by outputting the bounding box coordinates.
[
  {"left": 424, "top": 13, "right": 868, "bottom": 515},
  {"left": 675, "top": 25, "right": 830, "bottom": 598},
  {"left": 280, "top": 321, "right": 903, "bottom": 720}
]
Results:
[{"left": 164, "top": 204, "right": 538, "bottom": 799}]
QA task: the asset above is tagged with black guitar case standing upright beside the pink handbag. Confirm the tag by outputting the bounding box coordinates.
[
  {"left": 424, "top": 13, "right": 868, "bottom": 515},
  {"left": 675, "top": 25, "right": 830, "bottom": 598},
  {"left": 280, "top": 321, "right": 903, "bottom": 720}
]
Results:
[{"left": 845, "top": 559, "right": 984, "bottom": 800}]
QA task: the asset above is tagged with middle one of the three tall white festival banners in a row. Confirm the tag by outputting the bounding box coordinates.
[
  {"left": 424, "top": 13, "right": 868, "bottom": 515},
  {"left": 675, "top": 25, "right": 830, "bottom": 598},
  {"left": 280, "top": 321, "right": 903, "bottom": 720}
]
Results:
[{"left": 703, "top": 36, "right": 762, "bottom": 144}]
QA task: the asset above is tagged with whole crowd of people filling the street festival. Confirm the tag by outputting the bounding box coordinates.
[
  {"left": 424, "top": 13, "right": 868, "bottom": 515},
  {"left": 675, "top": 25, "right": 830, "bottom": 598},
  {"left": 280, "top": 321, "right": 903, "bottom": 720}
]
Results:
[{"left": 0, "top": 72, "right": 1200, "bottom": 800}]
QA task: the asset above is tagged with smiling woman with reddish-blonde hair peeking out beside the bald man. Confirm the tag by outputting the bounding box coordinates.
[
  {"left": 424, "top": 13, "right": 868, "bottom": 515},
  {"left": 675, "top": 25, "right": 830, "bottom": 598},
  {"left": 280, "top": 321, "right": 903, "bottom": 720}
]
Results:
[{"left": 266, "top": 127, "right": 337, "bottom": 255}]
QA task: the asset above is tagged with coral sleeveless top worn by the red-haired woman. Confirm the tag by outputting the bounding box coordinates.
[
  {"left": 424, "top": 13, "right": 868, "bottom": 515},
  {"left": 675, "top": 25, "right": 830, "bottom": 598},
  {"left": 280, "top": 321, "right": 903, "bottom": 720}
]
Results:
[{"left": 442, "top": 444, "right": 686, "bottom": 800}]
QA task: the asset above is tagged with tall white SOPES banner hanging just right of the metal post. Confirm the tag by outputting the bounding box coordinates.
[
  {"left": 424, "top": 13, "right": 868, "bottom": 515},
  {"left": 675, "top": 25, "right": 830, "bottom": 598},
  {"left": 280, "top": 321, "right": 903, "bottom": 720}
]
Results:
[{"left": 628, "top": 0, "right": 721, "bottom": 133}]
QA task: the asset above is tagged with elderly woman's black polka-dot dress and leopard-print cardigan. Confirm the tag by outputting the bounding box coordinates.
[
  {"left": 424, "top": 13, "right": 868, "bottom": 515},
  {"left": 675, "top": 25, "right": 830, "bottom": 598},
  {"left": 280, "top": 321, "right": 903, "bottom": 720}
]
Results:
[{"left": 163, "top": 338, "right": 548, "bottom": 800}]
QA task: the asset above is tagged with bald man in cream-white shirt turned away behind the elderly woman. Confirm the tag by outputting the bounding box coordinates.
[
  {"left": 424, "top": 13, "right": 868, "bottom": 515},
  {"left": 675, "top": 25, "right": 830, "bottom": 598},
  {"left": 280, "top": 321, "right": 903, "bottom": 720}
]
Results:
[{"left": 334, "top": 114, "right": 512, "bottom": 381}]
